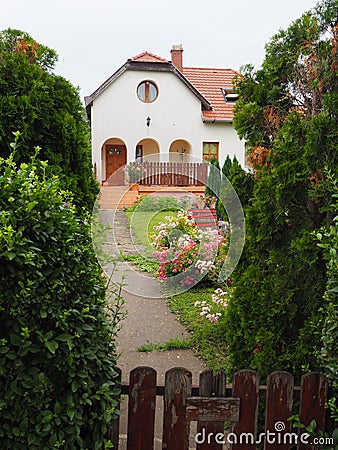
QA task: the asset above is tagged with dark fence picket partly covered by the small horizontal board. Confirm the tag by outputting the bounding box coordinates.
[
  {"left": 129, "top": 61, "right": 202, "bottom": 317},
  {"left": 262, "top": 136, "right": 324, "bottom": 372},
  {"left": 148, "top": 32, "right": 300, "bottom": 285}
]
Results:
[{"left": 196, "top": 370, "right": 226, "bottom": 450}]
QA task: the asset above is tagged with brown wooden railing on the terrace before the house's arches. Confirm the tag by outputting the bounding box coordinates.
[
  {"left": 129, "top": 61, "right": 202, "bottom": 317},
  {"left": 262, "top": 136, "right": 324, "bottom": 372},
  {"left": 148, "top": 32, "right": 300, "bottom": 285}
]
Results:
[{"left": 138, "top": 161, "right": 209, "bottom": 186}]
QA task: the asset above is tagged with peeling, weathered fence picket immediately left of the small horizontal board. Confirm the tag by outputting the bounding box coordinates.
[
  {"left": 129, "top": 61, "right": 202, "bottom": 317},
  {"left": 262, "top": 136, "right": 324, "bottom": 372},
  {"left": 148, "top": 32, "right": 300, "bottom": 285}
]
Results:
[{"left": 162, "top": 367, "right": 192, "bottom": 450}]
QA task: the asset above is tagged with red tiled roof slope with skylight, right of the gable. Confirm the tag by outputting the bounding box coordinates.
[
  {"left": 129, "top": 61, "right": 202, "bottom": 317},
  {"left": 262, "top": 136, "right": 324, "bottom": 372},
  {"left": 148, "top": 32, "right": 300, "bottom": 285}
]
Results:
[{"left": 182, "top": 67, "right": 237, "bottom": 121}]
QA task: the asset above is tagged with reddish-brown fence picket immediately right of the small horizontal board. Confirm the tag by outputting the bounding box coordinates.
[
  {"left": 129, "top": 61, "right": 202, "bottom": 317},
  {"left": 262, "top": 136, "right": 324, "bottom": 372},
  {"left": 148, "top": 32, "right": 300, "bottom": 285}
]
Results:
[{"left": 231, "top": 370, "right": 259, "bottom": 450}]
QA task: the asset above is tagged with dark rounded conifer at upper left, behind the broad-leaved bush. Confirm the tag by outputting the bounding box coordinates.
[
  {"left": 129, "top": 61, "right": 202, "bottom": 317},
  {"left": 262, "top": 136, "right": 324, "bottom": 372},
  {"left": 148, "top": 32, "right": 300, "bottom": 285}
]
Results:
[{"left": 0, "top": 30, "right": 98, "bottom": 209}]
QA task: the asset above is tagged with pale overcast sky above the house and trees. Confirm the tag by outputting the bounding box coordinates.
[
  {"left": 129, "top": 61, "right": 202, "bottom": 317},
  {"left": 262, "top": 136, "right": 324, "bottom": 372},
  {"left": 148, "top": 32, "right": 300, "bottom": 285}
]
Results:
[{"left": 0, "top": 0, "right": 317, "bottom": 99}]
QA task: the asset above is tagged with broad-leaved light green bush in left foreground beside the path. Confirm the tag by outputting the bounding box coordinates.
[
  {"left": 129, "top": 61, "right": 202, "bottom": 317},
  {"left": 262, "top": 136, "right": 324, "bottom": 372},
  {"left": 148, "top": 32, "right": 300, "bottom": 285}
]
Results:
[{"left": 0, "top": 158, "right": 121, "bottom": 450}]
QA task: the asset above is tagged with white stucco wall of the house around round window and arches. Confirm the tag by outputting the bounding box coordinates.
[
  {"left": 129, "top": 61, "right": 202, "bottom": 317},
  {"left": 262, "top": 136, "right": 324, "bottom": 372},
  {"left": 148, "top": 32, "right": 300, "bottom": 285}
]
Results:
[{"left": 91, "top": 70, "right": 244, "bottom": 180}]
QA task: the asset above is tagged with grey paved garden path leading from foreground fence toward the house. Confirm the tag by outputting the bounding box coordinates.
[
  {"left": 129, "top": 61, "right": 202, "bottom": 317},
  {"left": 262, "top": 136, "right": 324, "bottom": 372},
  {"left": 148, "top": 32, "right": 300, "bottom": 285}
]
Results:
[{"left": 100, "top": 210, "right": 206, "bottom": 450}]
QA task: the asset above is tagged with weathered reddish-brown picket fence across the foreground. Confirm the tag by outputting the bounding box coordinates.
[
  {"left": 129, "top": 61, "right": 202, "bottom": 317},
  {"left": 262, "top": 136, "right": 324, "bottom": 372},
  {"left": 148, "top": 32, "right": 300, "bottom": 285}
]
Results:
[{"left": 109, "top": 367, "right": 328, "bottom": 450}]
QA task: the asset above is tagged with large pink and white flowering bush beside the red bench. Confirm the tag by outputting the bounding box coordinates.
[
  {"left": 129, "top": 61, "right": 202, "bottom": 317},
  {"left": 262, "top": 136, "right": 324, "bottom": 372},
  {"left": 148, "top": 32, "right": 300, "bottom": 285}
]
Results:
[{"left": 152, "top": 211, "right": 227, "bottom": 288}]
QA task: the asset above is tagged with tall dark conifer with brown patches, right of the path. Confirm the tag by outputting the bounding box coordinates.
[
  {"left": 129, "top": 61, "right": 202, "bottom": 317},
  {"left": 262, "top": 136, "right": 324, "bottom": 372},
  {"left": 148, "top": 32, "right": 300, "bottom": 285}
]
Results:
[{"left": 225, "top": 0, "right": 338, "bottom": 377}]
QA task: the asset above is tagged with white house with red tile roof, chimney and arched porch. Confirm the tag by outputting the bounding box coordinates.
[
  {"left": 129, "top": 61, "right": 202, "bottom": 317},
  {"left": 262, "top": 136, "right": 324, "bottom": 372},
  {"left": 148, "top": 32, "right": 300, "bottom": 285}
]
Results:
[{"left": 85, "top": 45, "right": 245, "bottom": 184}]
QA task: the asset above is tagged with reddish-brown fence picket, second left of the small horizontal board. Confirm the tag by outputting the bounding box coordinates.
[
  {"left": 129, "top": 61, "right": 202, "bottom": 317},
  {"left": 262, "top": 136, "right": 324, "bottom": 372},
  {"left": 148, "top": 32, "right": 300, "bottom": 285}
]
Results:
[{"left": 127, "top": 367, "right": 156, "bottom": 450}]
